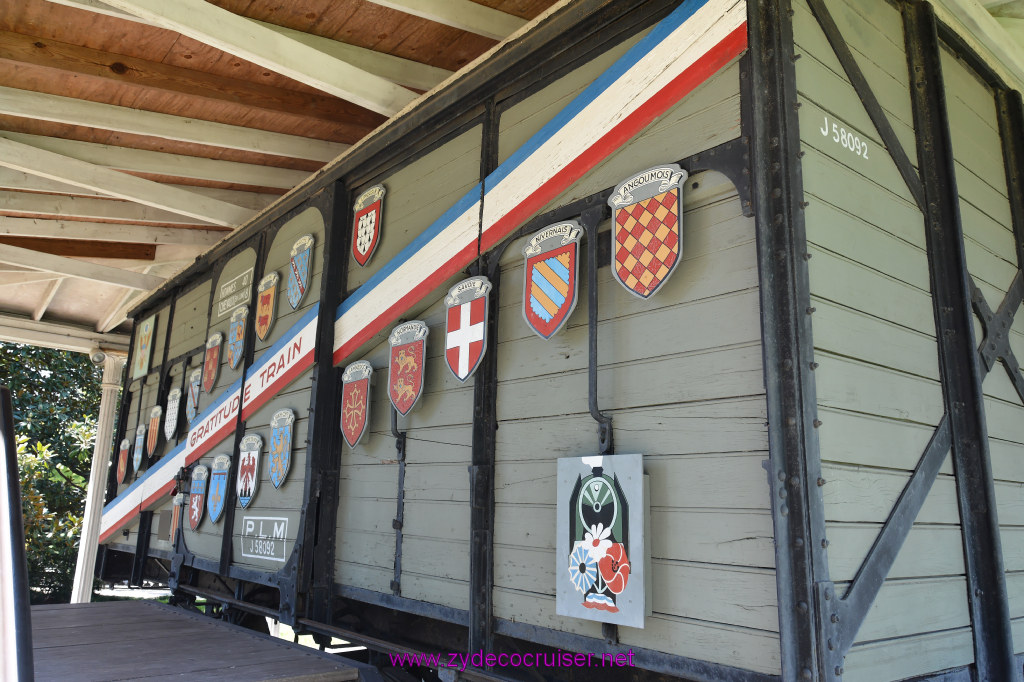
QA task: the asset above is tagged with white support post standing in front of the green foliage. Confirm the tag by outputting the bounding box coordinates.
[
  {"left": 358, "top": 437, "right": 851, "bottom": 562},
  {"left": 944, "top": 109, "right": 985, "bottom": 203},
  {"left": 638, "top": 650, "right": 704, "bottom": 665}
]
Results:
[{"left": 71, "top": 352, "right": 125, "bottom": 604}]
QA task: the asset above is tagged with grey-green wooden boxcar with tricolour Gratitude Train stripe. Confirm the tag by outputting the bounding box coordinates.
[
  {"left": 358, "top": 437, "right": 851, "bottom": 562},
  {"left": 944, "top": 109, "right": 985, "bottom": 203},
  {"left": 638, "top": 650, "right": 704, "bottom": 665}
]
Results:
[{"left": 98, "top": 0, "right": 1024, "bottom": 682}]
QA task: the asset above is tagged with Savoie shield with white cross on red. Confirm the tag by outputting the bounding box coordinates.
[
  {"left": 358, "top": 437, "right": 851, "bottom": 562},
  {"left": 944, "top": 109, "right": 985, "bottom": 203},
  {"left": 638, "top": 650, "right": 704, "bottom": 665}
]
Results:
[{"left": 444, "top": 276, "right": 490, "bottom": 381}]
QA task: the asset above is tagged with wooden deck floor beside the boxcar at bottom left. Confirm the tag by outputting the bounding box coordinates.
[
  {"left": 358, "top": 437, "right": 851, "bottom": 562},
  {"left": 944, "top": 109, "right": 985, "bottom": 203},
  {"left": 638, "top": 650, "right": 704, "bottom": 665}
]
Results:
[{"left": 32, "top": 600, "right": 359, "bottom": 682}]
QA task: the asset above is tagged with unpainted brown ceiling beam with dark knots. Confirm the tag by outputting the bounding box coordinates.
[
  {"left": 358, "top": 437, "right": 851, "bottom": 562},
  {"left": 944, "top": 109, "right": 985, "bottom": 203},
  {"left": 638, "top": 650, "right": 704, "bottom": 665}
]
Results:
[{"left": 0, "top": 31, "right": 385, "bottom": 134}]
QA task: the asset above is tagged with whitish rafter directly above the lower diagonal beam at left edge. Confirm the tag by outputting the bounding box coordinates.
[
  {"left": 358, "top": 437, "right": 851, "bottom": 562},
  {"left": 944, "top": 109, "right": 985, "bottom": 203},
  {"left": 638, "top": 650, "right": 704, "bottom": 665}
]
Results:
[{"left": 0, "top": 131, "right": 309, "bottom": 189}]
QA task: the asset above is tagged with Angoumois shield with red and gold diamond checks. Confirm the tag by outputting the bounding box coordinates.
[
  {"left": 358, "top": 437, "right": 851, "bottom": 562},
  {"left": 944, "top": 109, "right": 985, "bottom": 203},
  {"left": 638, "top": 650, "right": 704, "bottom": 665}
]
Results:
[{"left": 608, "top": 164, "right": 687, "bottom": 298}]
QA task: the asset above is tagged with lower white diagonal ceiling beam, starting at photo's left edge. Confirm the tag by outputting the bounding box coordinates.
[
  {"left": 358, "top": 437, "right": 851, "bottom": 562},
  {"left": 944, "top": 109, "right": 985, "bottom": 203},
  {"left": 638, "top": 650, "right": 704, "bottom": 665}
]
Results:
[{"left": 0, "top": 137, "right": 254, "bottom": 227}]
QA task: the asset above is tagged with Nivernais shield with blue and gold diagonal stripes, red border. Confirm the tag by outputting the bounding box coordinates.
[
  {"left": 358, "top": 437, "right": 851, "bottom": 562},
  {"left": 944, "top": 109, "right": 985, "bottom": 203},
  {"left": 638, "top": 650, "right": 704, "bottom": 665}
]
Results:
[{"left": 522, "top": 220, "right": 583, "bottom": 339}]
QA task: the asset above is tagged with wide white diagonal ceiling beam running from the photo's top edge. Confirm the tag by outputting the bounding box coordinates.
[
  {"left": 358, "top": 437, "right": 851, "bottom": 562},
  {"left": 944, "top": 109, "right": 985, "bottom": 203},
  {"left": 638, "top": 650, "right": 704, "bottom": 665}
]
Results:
[{"left": 106, "top": 0, "right": 419, "bottom": 116}]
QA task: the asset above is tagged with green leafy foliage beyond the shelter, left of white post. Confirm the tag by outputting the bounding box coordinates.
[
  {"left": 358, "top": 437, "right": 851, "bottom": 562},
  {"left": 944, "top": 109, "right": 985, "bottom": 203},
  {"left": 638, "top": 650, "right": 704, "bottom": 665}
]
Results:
[{"left": 0, "top": 343, "right": 101, "bottom": 602}]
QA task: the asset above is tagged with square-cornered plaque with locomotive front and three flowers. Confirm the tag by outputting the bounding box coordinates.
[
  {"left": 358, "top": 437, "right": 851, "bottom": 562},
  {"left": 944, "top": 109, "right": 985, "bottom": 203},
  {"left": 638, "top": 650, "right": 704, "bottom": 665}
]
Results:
[{"left": 555, "top": 455, "right": 647, "bottom": 628}]
